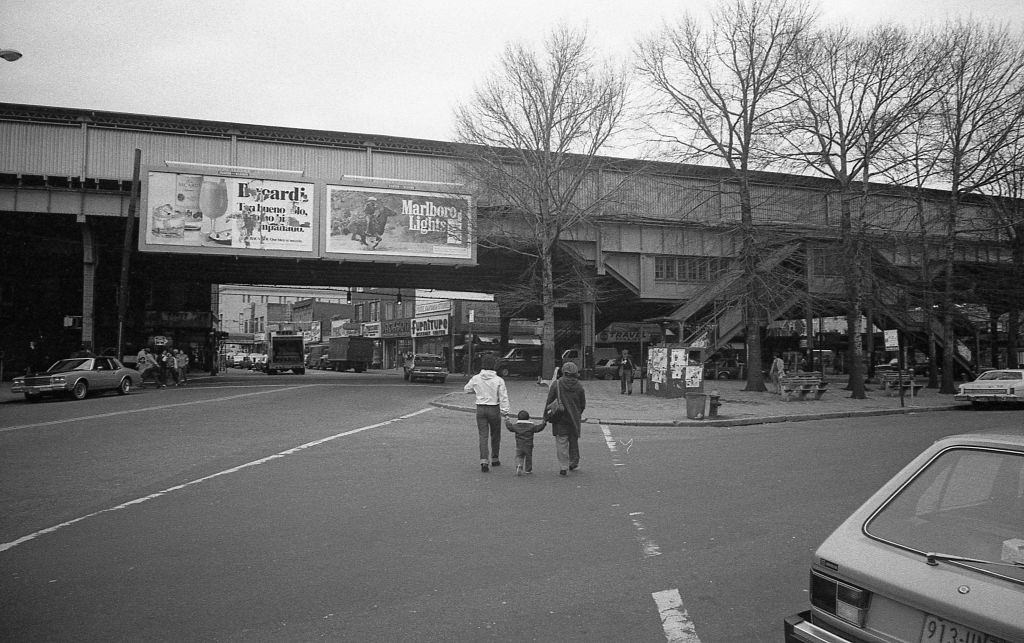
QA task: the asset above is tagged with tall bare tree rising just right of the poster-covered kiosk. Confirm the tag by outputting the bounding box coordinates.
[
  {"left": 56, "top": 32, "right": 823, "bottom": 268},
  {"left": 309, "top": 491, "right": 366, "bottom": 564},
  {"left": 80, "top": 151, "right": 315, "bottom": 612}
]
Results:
[{"left": 638, "top": 0, "right": 815, "bottom": 391}]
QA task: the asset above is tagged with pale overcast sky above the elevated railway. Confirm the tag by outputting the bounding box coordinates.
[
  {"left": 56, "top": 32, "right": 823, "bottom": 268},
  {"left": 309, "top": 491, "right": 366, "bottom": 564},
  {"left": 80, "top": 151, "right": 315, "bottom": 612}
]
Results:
[{"left": 0, "top": 0, "right": 1024, "bottom": 140}]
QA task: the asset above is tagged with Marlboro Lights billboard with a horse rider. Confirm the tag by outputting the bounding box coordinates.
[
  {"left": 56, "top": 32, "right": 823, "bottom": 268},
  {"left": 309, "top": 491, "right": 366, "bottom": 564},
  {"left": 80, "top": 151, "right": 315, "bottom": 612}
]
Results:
[{"left": 324, "top": 184, "right": 476, "bottom": 264}]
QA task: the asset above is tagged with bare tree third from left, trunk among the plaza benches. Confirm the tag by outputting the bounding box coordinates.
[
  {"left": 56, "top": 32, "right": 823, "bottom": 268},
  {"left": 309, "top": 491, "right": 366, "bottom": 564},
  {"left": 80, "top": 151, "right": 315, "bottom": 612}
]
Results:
[{"left": 784, "top": 26, "right": 935, "bottom": 399}]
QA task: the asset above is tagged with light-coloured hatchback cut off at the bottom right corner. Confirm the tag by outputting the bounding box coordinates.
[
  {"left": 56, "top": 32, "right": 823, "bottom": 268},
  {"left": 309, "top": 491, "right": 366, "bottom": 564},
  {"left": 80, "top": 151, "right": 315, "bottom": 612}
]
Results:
[{"left": 783, "top": 434, "right": 1024, "bottom": 643}]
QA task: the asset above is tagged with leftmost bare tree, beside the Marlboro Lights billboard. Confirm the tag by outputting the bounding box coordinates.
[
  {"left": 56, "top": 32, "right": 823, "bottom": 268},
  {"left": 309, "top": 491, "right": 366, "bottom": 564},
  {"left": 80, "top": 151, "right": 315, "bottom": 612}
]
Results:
[{"left": 456, "top": 28, "right": 628, "bottom": 373}]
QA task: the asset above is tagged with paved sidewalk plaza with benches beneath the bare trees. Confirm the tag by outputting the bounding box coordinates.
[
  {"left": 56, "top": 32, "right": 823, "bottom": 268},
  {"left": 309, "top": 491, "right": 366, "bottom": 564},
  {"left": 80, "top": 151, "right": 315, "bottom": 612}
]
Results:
[{"left": 434, "top": 375, "right": 964, "bottom": 426}]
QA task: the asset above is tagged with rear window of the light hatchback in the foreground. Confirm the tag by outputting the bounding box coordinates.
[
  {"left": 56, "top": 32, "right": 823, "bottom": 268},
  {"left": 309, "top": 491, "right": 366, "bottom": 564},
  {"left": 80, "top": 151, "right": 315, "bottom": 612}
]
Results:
[{"left": 864, "top": 447, "right": 1024, "bottom": 583}]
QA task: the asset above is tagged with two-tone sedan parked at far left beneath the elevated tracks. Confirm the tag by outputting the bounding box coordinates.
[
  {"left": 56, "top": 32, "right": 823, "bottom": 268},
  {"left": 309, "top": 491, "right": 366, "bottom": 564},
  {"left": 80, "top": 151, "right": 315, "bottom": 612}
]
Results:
[{"left": 10, "top": 357, "right": 142, "bottom": 401}]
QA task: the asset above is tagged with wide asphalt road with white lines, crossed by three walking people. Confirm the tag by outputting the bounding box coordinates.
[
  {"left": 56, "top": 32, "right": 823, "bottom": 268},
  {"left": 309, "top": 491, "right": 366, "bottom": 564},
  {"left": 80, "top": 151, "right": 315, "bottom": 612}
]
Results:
[{"left": 0, "top": 371, "right": 1021, "bottom": 643}]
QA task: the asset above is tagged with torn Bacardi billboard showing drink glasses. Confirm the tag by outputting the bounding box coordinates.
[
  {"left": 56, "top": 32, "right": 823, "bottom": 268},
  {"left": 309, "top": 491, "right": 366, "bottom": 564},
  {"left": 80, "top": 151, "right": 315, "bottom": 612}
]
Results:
[{"left": 139, "top": 169, "right": 319, "bottom": 257}]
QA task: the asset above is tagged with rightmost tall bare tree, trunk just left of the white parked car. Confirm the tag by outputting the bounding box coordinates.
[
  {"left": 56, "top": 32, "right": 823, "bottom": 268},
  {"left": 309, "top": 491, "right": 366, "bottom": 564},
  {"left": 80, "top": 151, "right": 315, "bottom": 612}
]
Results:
[{"left": 935, "top": 22, "right": 1024, "bottom": 394}]
